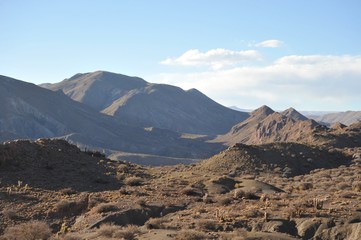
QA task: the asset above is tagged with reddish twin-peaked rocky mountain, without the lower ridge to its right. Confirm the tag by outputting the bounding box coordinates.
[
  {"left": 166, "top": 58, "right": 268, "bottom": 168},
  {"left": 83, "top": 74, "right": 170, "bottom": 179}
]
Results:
[{"left": 214, "top": 106, "right": 319, "bottom": 145}]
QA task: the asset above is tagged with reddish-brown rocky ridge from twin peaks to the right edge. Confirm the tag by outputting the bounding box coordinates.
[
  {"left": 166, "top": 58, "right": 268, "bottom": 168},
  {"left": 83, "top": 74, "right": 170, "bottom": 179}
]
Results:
[{"left": 212, "top": 106, "right": 360, "bottom": 147}]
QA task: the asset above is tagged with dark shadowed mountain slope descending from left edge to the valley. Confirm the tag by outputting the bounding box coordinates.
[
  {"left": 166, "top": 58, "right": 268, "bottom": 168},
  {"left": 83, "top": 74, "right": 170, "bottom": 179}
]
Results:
[{"left": 0, "top": 76, "right": 222, "bottom": 159}]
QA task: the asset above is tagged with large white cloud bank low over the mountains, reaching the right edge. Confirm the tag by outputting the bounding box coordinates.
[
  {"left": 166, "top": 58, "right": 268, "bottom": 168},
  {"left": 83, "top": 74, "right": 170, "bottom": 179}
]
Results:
[{"left": 154, "top": 55, "right": 361, "bottom": 110}]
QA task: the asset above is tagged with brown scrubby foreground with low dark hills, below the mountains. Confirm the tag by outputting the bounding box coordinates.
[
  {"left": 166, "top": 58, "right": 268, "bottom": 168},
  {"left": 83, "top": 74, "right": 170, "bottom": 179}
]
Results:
[{"left": 0, "top": 121, "right": 361, "bottom": 240}]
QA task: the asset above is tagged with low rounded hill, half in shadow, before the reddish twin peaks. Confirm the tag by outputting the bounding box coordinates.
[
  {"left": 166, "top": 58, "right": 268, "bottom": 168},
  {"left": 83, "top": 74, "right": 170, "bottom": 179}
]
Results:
[{"left": 198, "top": 142, "right": 352, "bottom": 177}]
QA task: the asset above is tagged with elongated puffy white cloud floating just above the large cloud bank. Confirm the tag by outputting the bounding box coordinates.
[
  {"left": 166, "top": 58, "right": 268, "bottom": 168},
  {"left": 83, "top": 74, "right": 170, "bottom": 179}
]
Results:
[{"left": 161, "top": 48, "right": 262, "bottom": 69}]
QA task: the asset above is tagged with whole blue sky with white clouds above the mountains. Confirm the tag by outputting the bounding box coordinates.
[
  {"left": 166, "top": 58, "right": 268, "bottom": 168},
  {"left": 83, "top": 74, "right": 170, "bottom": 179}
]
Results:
[{"left": 0, "top": 0, "right": 361, "bottom": 111}]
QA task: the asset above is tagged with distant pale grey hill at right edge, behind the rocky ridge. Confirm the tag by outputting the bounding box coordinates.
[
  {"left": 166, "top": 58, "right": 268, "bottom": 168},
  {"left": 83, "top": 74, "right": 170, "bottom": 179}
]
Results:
[{"left": 314, "top": 111, "right": 361, "bottom": 125}]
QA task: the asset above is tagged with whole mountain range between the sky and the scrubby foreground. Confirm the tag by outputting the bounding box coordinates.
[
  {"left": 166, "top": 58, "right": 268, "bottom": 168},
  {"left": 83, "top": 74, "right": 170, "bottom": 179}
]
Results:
[{"left": 0, "top": 71, "right": 358, "bottom": 165}]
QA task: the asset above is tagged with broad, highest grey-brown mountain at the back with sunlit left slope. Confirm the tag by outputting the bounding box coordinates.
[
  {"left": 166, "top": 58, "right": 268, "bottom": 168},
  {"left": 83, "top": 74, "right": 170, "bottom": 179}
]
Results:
[{"left": 42, "top": 71, "right": 248, "bottom": 135}]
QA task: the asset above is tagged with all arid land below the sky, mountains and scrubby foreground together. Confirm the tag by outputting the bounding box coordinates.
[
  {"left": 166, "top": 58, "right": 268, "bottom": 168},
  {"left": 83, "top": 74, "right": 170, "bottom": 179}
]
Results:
[{"left": 0, "top": 71, "right": 361, "bottom": 240}]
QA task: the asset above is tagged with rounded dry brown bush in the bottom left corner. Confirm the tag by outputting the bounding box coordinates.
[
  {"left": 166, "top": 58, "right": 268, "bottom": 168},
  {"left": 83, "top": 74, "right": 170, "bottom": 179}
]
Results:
[{"left": 4, "top": 221, "right": 51, "bottom": 240}]
